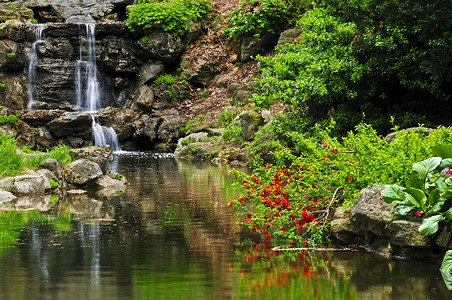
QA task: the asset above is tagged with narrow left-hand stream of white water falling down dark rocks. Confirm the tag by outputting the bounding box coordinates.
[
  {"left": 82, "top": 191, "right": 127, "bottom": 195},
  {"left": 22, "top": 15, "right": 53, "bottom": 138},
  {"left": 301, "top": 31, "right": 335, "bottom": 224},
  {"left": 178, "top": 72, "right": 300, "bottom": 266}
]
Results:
[{"left": 27, "top": 24, "right": 44, "bottom": 109}]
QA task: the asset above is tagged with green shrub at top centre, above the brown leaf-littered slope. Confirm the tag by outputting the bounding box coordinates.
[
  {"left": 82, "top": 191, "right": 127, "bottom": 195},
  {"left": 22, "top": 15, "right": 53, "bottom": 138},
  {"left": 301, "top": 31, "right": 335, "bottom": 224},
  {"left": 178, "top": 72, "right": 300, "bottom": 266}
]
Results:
[{"left": 224, "top": 0, "right": 311, "bottom": 38}]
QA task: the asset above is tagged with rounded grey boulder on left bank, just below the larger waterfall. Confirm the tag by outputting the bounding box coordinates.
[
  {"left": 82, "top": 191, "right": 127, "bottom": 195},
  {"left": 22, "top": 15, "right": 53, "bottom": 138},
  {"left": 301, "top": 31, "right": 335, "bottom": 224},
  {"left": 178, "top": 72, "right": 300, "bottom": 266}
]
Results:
[{"left": 65, "top": 158, "right": 103, "bottom": 185}]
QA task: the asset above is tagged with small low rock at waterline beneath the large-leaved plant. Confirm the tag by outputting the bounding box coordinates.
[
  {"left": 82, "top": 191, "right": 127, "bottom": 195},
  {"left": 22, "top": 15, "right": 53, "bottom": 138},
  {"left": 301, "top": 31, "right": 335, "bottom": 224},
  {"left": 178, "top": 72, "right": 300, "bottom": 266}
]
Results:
[{"left": 387, "top": 220, "right": 430, "bottom": 248}]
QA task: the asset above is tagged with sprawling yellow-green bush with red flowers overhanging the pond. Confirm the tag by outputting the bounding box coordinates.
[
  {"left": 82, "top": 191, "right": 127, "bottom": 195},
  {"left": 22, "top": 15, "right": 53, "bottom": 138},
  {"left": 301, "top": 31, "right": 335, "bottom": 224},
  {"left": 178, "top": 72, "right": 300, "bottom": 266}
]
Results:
[{"left": 230, "top": 122, "right": 452, "bottom": 245}]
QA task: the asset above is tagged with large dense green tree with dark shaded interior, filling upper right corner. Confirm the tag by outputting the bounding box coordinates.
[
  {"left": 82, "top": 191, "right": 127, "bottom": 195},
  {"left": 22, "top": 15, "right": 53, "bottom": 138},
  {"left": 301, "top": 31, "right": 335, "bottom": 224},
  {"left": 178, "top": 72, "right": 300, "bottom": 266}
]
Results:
[{"left": 254, "top": 0, "right": 452, "bottom": 134}]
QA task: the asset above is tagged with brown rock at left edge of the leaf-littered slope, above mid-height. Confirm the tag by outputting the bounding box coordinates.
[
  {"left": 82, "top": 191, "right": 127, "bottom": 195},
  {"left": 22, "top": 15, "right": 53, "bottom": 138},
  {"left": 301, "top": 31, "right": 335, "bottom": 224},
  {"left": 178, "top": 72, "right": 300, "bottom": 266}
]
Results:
[{"left": 180, "top": 57, "right": 214, "bottom": 87}]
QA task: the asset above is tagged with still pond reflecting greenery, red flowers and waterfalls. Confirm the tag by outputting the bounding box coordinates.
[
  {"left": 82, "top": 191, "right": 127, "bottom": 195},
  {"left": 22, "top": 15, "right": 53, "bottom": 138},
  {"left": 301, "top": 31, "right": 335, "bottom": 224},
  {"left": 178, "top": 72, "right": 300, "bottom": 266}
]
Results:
[{"left": 0, "top": 153, "right": 451, "bottom": 299}]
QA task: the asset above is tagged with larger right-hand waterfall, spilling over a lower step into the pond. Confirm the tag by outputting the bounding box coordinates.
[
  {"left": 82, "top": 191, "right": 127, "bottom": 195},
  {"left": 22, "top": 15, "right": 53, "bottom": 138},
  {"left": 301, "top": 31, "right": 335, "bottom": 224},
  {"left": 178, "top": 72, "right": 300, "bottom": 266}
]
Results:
[{"left": 75, "top": 24, "right": 121, "bottom": 152}]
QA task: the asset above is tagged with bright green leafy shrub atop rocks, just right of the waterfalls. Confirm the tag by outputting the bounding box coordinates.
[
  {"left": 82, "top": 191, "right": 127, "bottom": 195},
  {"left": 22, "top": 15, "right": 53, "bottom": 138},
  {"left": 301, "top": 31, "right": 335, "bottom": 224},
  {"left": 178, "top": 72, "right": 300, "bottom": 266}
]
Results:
[{"left": 125, "top": 0, "right": 211, "bottom": 35}]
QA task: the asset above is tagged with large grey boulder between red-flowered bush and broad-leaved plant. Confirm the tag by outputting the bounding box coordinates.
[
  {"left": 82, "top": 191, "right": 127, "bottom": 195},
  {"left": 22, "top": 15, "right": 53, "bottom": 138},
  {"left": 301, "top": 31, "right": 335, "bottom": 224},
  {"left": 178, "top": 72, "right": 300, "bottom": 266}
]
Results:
[{"left": 350, "top": 184, "right": 395, "bottom": 238}]
